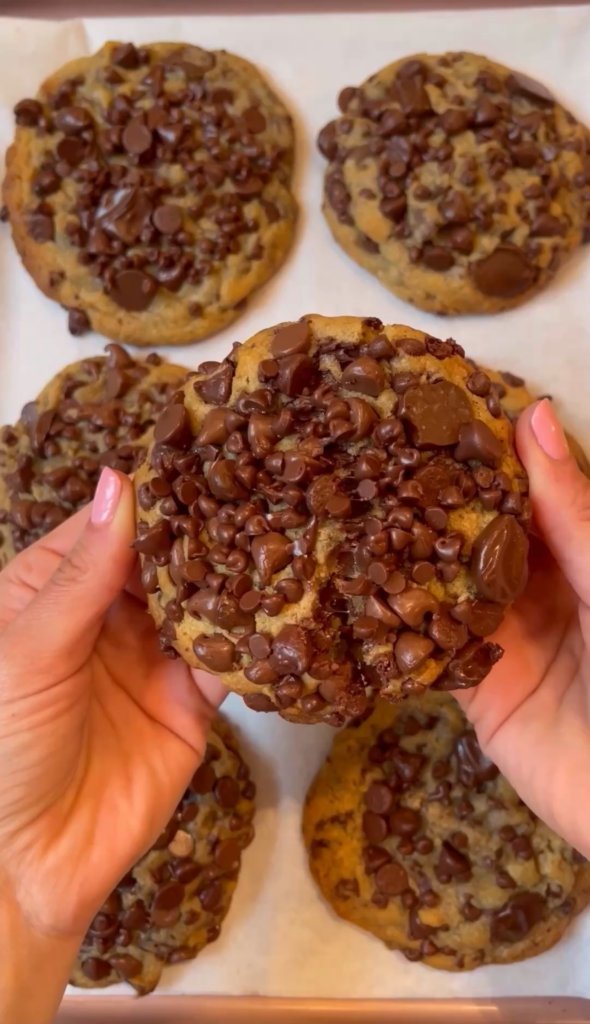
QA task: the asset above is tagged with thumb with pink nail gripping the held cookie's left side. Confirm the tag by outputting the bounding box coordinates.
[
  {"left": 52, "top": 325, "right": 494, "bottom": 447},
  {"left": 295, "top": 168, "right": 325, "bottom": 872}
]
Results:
[{"left": 13, "top": 468, "right": 136, "bottom": 672}]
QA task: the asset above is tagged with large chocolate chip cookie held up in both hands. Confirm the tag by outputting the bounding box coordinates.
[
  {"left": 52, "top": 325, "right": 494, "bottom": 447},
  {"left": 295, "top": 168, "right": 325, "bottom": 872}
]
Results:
[{"left": 135, "top": 315, "right": 530, "bottom": 725}]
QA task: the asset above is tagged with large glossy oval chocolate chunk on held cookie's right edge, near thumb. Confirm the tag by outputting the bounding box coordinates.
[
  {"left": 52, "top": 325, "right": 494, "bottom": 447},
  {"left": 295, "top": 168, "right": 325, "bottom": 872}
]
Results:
[{"left": 471, "top": 515, "right": 529, "bottom": 604}]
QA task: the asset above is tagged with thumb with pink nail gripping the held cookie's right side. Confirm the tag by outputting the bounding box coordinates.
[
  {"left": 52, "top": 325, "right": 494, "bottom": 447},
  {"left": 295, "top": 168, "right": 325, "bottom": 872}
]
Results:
[{"left": 516, "top": 398, "right": 590, "bottom": 605}]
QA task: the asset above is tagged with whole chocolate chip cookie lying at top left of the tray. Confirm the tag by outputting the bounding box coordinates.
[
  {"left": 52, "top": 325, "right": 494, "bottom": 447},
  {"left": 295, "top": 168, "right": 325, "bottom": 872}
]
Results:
[{"left": 4, "top": 43, "right": 296, "bottom": 345}]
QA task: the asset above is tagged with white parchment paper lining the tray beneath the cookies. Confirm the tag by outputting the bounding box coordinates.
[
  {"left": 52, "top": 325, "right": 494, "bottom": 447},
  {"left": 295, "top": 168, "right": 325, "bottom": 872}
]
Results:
[{"left": 0, "top": 7, "right": 590, "bottom": 998}]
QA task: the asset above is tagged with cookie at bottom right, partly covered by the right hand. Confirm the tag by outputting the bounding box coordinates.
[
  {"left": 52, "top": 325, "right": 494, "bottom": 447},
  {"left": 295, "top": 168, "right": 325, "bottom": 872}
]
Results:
[{"left": 303, "top": 693, "right": 590, "bottom": 971}]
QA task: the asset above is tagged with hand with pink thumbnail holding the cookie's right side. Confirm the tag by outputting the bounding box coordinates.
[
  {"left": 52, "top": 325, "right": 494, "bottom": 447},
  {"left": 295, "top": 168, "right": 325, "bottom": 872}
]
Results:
[{"left": 455, "top": 399, "right": 590, "bottom": 858}]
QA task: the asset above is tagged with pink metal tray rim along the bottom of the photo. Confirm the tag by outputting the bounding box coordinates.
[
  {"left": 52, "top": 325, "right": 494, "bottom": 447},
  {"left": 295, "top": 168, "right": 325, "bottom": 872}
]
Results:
[{"left": 55, "top": 995, "right": 590, "bottom": 1024}]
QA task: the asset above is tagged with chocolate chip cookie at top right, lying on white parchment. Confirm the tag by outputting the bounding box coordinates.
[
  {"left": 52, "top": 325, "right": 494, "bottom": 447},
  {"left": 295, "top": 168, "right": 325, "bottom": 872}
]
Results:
[{"left": 318, "top": 53, "right": 590, "bottom": 315}]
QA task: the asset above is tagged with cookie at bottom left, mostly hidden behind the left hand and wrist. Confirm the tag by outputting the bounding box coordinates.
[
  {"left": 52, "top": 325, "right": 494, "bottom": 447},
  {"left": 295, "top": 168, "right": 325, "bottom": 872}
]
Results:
[{"left": 71, "top": 717, "right": 256, "bottom": 995}]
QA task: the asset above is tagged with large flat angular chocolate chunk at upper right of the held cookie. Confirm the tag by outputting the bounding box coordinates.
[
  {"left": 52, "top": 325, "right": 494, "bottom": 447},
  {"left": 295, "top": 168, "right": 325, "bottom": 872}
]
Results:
[{"left": 398, "top": 381, "right": 473, "bottom": 447}]
